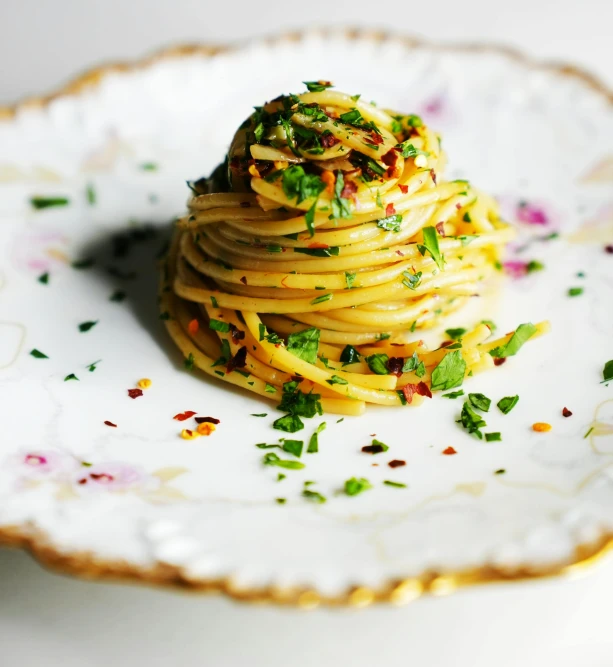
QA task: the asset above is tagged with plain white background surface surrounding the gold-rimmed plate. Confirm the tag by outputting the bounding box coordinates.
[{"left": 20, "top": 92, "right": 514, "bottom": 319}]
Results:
[{"left": 0, "top": 0, "right": 613, "bottom": 667}]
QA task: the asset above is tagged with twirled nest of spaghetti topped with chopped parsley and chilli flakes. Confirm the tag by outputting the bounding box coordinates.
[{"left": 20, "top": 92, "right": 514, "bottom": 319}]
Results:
[{"left": 161, "top": 82, "right": 542, "bottom": 416}]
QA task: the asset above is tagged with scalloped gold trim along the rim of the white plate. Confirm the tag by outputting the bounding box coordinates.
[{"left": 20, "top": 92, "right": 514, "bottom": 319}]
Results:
[{"left": 0, "top": 29, "right": 613, "bottom": 609}]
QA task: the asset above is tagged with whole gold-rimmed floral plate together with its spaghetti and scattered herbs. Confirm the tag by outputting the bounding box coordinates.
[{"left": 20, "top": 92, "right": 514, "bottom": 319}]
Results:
[{"left": 0, "top": 32, "right": 613, "bottom": 607}]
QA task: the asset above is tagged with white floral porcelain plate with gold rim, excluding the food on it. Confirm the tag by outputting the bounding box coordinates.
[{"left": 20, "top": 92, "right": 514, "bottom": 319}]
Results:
[{"left": 0, "top": 32, "right": 613, "bottom": 604}]
